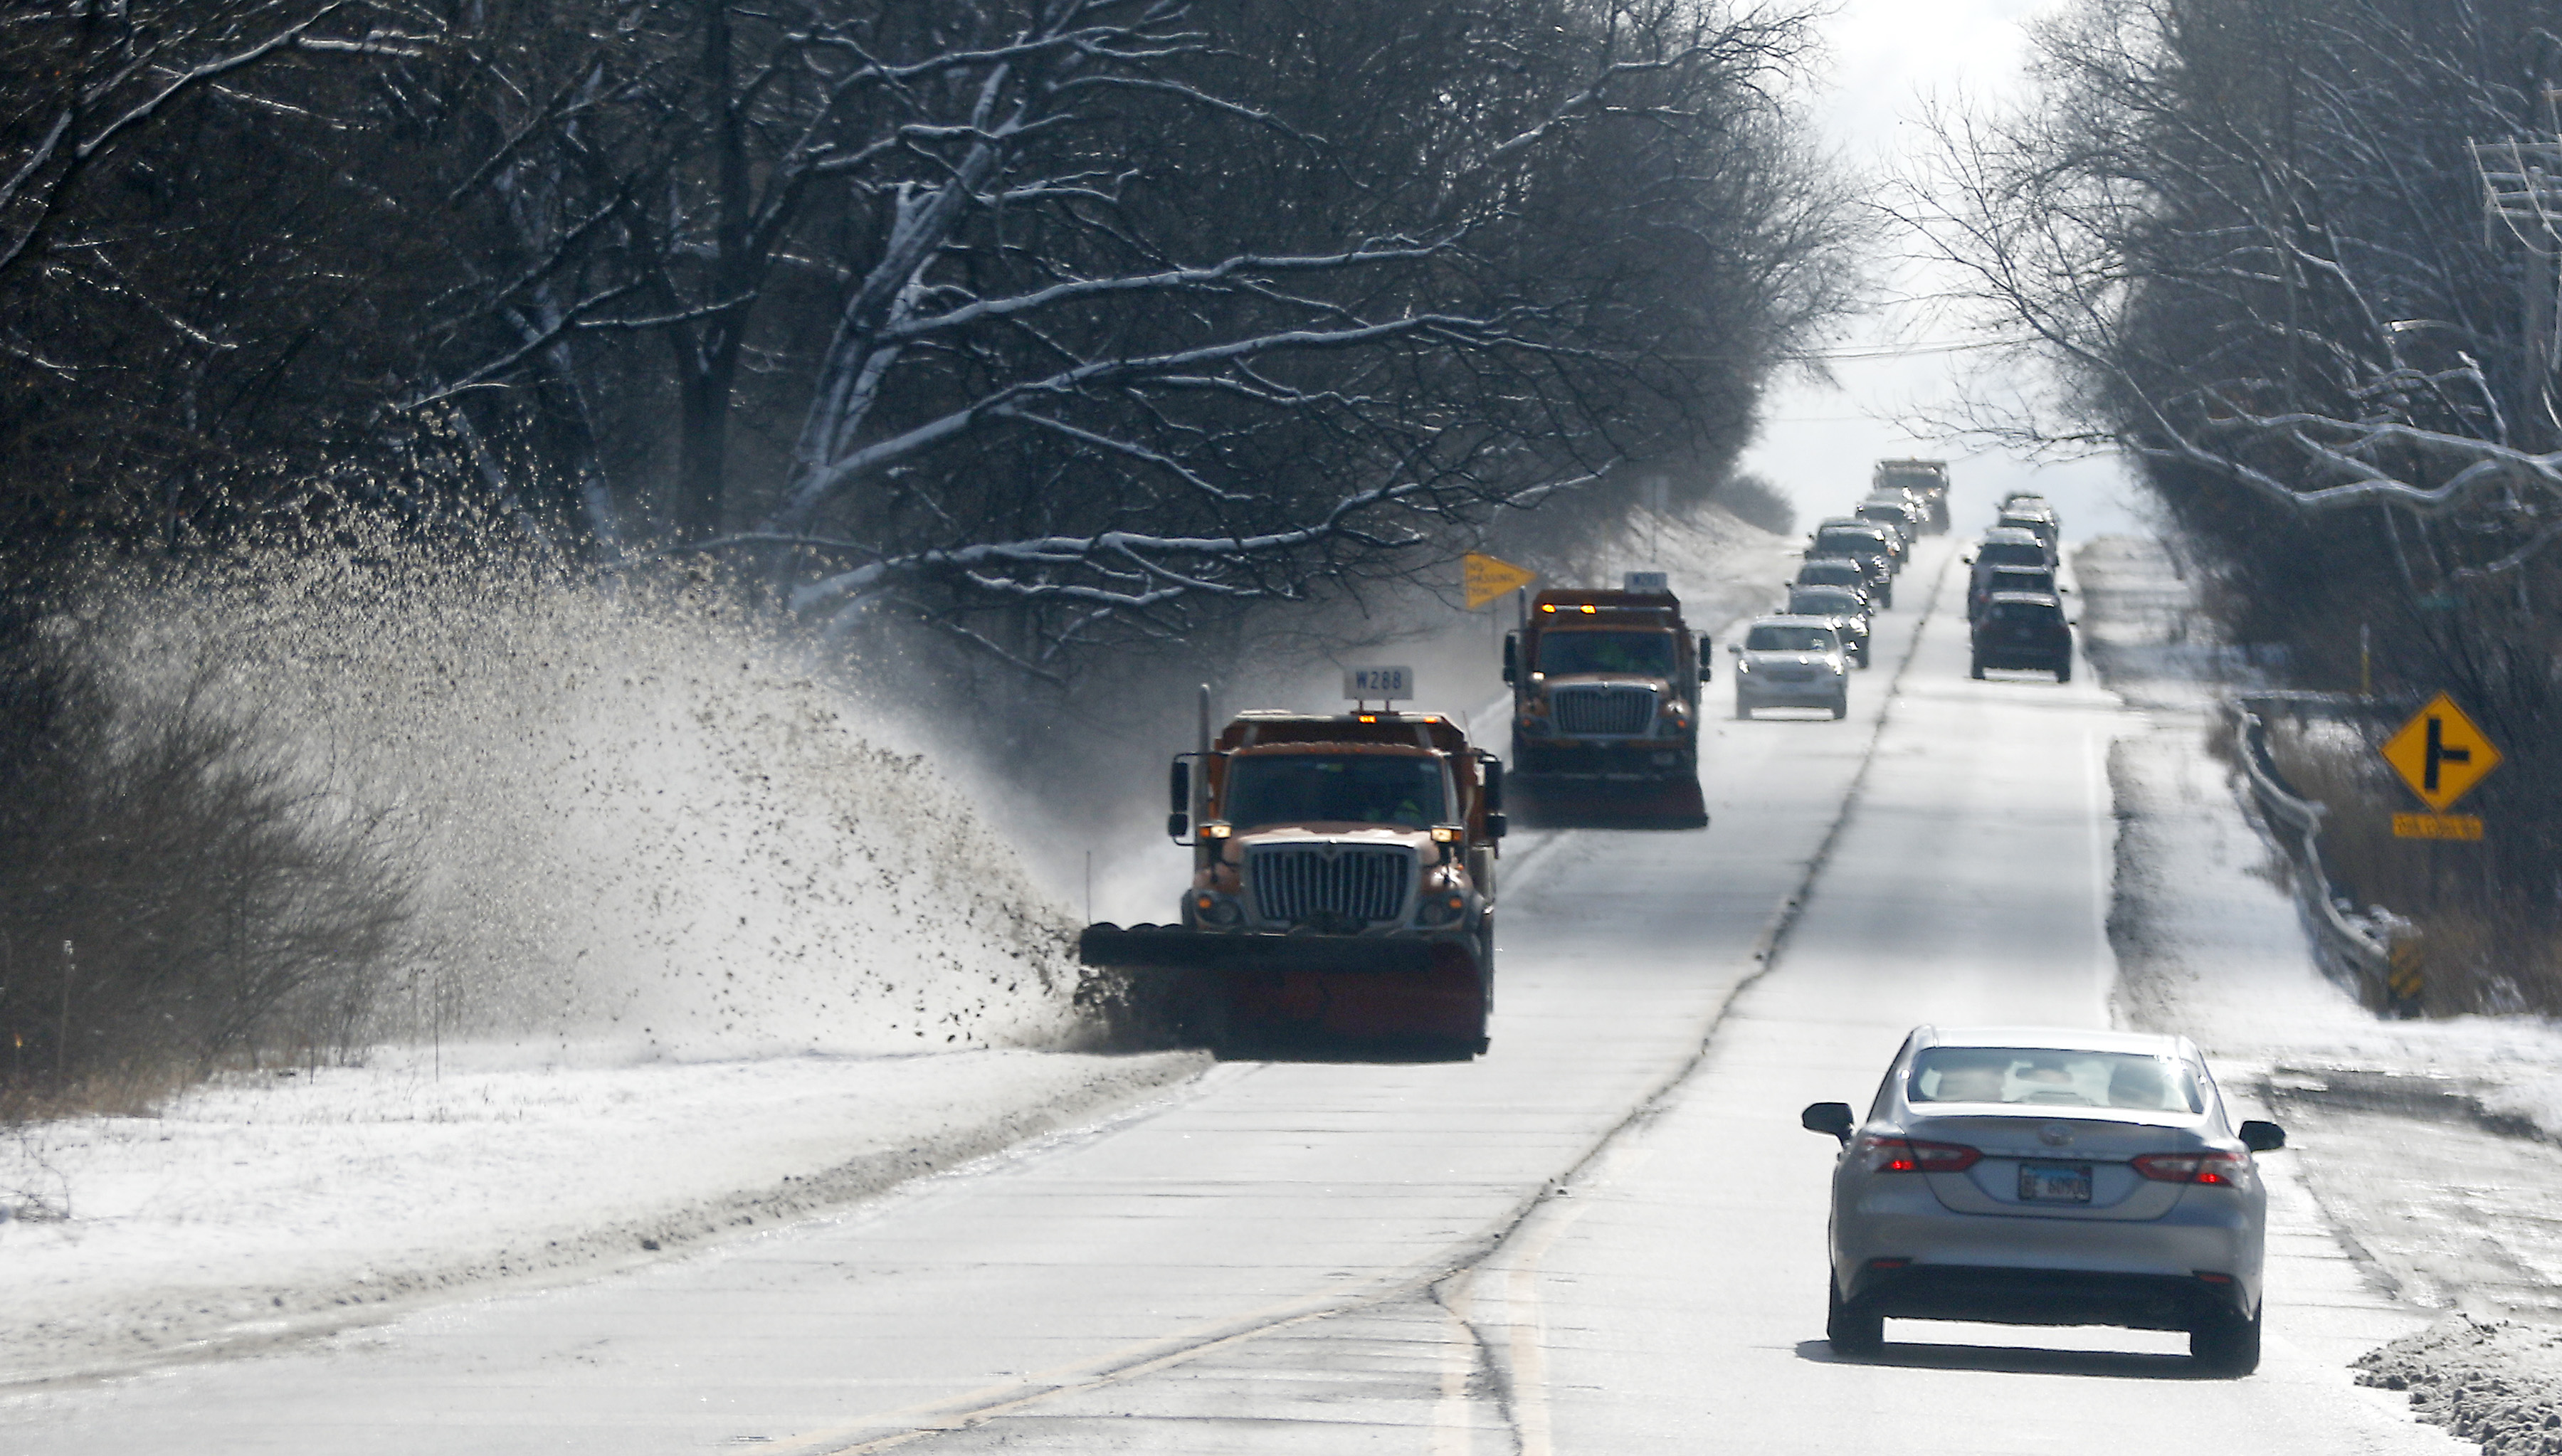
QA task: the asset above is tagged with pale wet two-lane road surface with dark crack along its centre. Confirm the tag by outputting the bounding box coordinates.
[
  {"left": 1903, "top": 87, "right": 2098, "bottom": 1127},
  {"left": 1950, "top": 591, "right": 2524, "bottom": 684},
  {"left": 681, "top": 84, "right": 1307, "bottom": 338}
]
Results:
[{"left": 0, "top": 544, "right": 2455, "bottom": 1456}]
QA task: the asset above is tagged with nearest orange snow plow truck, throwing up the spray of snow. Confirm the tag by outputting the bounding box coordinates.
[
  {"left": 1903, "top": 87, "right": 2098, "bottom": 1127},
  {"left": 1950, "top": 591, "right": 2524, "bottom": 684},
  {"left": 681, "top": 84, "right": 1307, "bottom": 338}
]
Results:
[{"left": 1076, "top": 669, "right": 1504, "bottom": 1059}]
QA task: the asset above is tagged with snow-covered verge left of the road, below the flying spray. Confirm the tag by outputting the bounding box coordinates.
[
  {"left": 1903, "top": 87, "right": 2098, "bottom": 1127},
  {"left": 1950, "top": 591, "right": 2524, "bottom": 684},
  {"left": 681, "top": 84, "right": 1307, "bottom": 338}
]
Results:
[{"left": 0, "top": 1046, "right": 1207, "bottom": 1382}]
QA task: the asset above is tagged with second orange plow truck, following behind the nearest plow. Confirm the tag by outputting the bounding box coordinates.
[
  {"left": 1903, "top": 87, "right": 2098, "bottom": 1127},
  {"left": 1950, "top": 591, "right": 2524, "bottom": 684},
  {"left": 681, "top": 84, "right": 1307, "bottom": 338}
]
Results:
[{"left": 1504, "top": 574, "right": 1709, "bottom": 828}]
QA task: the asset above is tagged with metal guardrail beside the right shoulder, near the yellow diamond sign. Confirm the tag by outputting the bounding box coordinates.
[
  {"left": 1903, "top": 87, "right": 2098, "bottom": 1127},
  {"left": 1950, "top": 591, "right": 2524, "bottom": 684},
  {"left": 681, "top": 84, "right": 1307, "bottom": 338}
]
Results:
[{"left": 2224, "top": 692, "right": 2421, "bottom": 1013}]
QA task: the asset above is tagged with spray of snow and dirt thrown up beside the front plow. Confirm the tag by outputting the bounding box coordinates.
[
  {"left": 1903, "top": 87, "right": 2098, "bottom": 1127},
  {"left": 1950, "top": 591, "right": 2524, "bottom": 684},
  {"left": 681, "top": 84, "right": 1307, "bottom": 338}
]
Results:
[{"left": 97, "top": 549, "right": 1076, "bottom": 1061}]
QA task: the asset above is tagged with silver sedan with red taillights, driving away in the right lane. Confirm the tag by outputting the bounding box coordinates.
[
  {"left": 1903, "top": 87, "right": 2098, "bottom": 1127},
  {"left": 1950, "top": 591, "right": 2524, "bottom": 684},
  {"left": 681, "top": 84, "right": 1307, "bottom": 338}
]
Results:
[{"left": 1803, "top": 1025, "right": 2285, "bottom": 1374}]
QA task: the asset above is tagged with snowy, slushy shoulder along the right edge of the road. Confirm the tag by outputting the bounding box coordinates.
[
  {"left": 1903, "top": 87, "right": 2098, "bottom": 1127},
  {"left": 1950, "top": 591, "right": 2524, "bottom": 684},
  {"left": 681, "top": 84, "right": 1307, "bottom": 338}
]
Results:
[{"left": 2075, "top": 538, "right": 2562, "bottom": 1456}]
